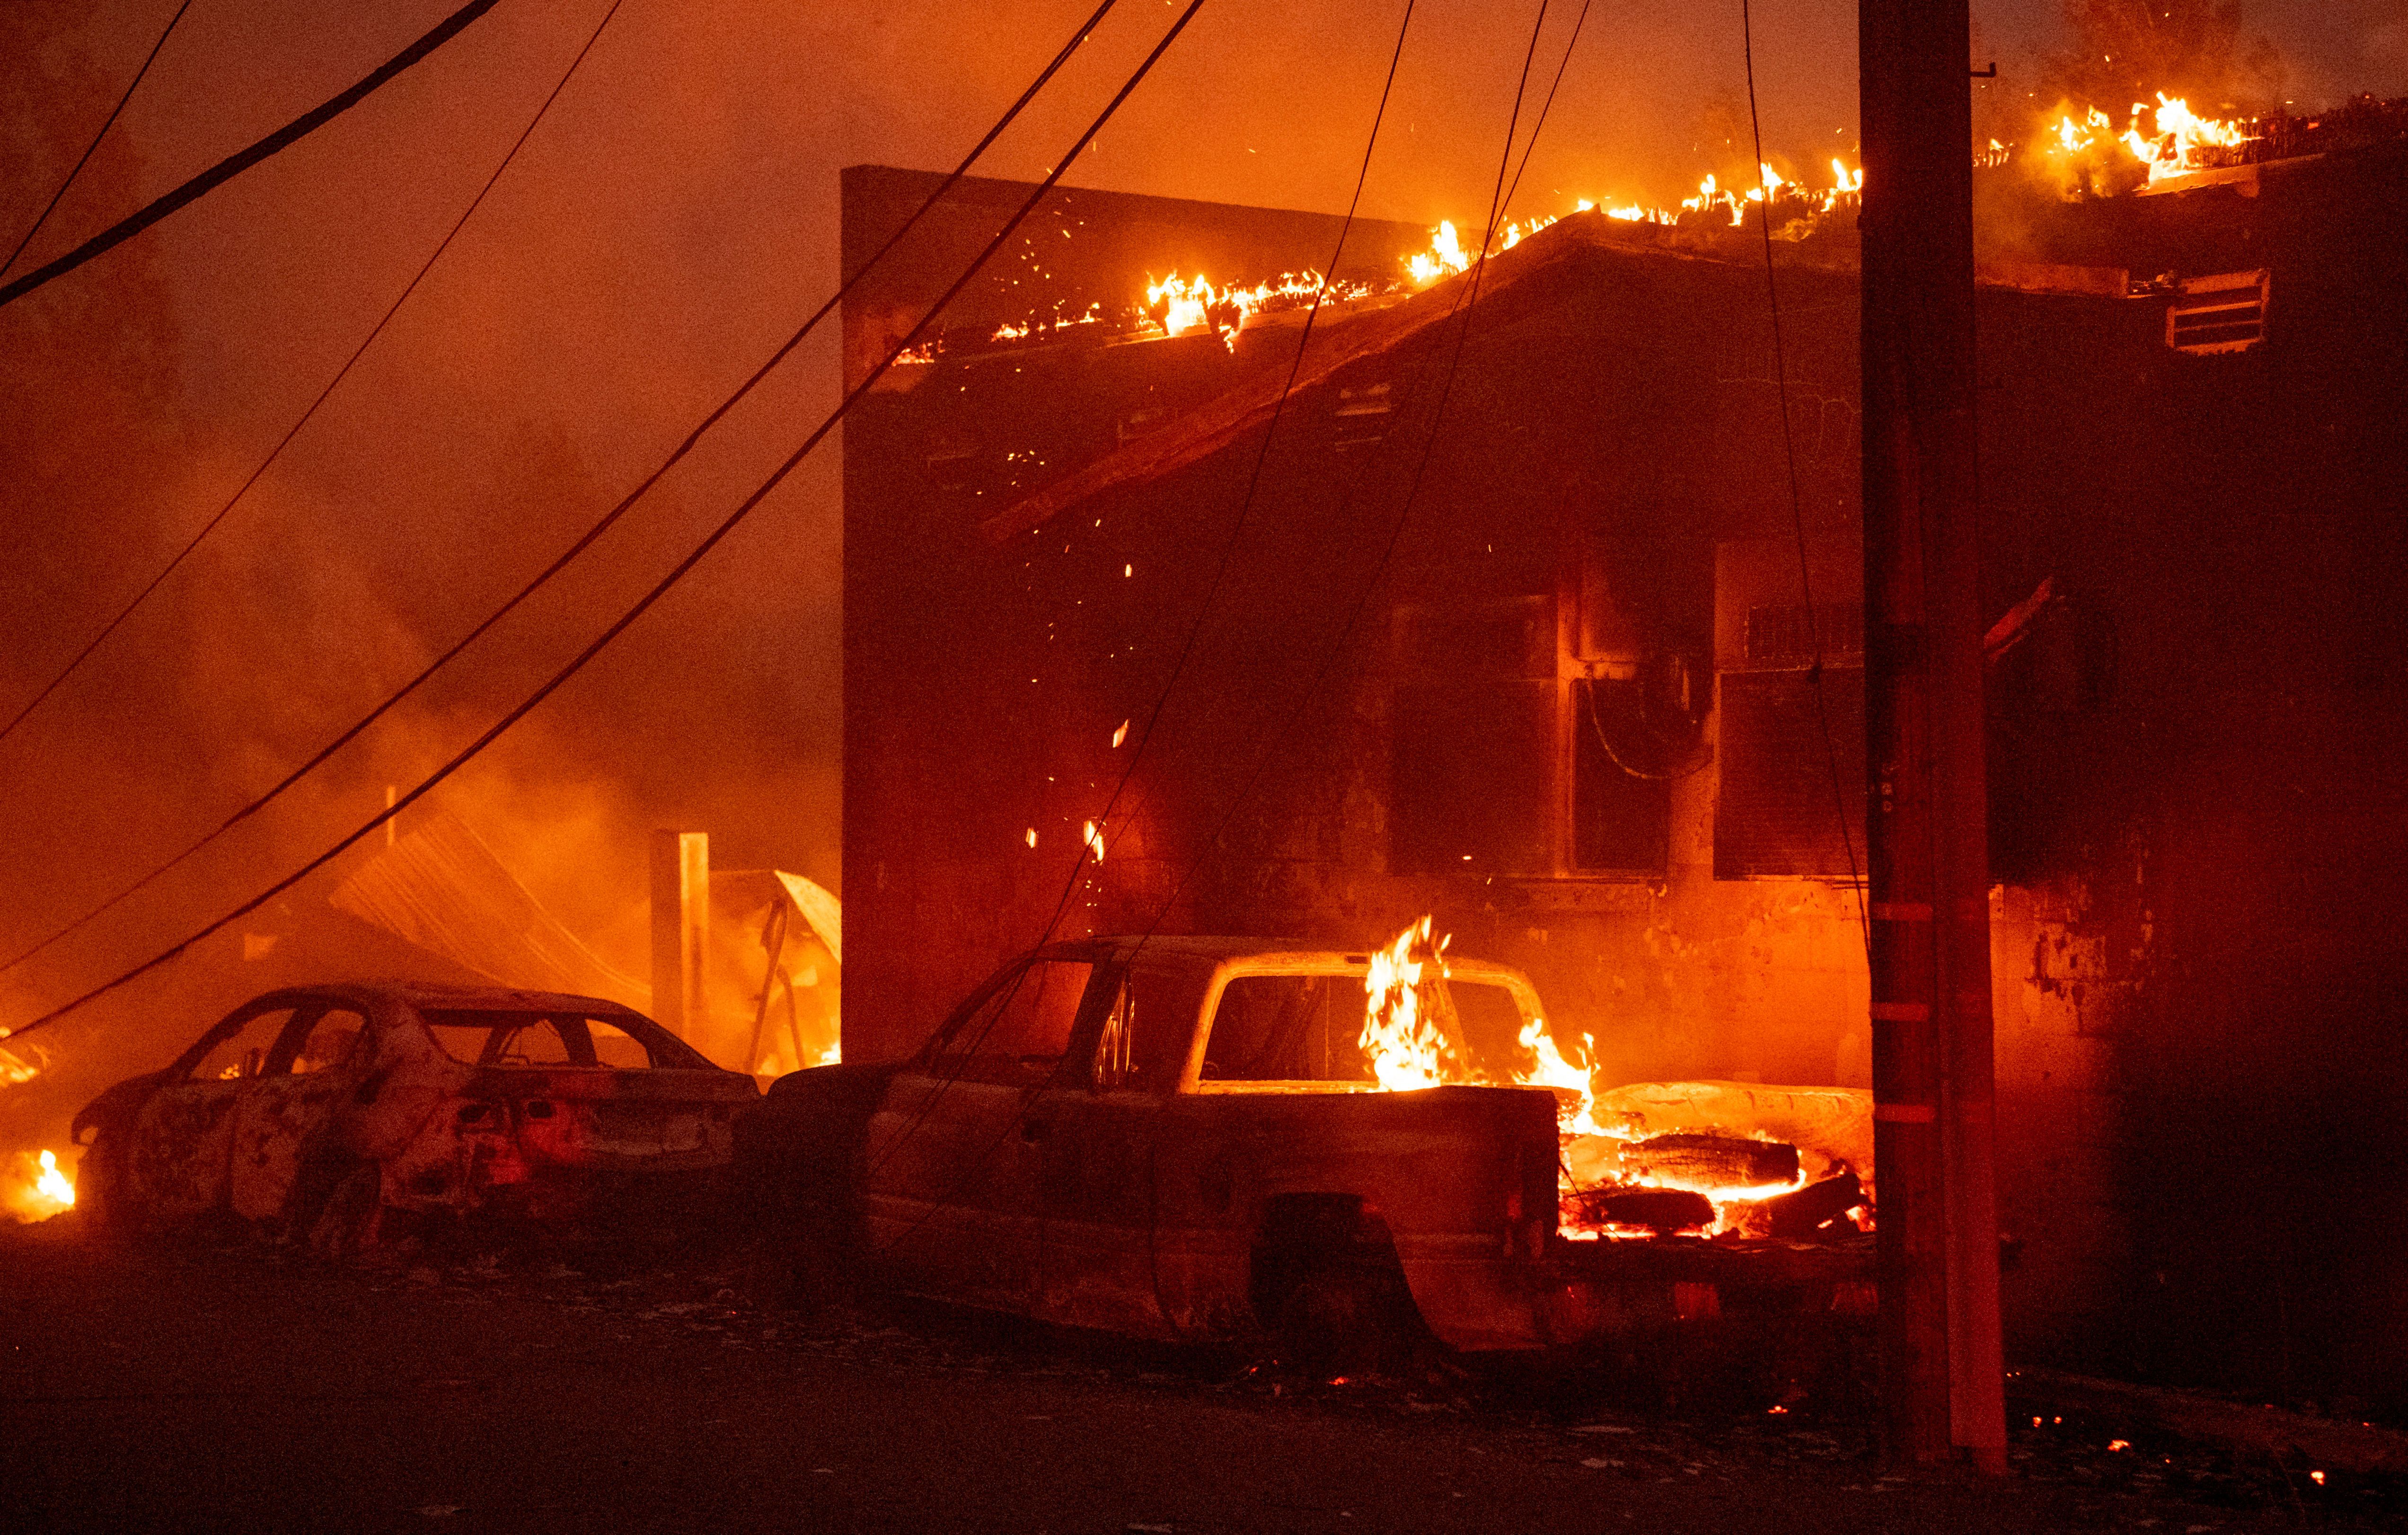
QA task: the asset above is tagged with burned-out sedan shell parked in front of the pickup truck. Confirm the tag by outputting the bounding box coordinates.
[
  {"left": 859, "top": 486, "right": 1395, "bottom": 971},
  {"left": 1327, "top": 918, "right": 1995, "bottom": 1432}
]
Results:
[{"left": 75, "top": 983, "right": 759, "bottom": 1253}]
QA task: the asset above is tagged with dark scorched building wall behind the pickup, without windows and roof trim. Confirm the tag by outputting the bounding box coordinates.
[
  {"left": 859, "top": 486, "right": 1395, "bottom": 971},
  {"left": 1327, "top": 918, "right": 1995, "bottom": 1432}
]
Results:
[{"left": 845, "top": 157, "right": 2408, "bottom": 1402}]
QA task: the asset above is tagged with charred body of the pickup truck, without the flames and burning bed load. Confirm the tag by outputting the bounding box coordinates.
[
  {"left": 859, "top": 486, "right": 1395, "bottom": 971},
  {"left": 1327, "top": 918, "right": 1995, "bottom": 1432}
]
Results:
[{"left": 737, "top": 937, "right": 1869, "bottom": 1349}]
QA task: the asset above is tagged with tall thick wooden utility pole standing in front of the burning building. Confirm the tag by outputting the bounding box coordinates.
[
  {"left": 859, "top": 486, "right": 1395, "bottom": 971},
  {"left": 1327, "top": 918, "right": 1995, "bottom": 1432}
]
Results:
[{"left": 1857, "top": 0, "right": 2006, "bottom": 1473}]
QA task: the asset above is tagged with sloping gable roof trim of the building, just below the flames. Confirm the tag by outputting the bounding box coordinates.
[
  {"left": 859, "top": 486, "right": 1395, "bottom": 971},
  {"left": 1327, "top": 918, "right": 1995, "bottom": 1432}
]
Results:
[{"left": 978, "top": 210, "right": 2129, "bottom": 545}]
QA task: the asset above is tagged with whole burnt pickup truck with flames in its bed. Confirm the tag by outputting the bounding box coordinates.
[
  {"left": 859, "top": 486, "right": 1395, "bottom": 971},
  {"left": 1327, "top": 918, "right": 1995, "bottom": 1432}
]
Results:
[{"left": 737, "top": 921, "right": 1871, "bottom": 1354}]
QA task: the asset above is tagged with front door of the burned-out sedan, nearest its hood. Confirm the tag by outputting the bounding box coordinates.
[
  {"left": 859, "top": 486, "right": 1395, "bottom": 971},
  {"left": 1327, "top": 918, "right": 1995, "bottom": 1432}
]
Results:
[{"left": 128, "top": 995, "right": 296, "bottom": 1219}]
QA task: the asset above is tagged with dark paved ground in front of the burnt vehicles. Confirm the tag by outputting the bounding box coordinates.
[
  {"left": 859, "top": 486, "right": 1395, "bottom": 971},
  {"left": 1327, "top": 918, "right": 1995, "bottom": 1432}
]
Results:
[{"left": 0, "top": 1217, "right": 2393, "bottom": 1535}]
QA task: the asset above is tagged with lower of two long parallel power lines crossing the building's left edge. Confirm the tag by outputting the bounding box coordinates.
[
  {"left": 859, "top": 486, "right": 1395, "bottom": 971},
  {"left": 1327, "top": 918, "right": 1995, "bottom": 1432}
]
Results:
[{"left": 12, "top": 0, "right": 1204, "bottom": 1034}]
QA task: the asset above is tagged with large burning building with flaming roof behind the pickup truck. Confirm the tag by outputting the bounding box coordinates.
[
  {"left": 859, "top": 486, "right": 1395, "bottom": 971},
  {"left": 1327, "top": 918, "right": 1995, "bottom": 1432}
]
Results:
[{"left": 843, "top": 114, "right": 2408, "bottom": 1398}]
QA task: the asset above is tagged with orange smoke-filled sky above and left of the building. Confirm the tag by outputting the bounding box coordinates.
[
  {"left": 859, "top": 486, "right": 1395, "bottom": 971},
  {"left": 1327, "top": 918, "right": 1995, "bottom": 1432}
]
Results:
[{"left": 0, "top": 0, "right": 2408, "bottom": 1017}]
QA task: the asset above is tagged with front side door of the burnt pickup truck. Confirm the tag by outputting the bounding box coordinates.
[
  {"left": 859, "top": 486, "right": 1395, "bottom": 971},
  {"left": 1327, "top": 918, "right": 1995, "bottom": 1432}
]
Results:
[{"left": 862, "top": 957, "right": 1093, "bottom": 1311}]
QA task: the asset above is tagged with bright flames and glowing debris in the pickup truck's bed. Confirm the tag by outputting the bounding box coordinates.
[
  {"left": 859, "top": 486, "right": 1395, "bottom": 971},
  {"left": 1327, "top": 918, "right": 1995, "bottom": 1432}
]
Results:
[{"left": 1358, "top": 916, "right": 1873, "bottom": 1241}]
